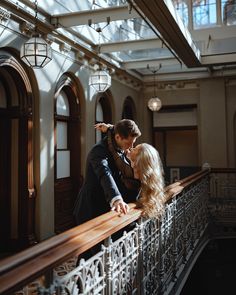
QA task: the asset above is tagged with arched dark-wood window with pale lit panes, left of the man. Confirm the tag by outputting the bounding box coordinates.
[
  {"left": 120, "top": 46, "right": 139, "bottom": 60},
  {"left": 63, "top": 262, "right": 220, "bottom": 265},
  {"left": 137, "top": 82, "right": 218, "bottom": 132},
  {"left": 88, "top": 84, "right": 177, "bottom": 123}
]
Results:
[{"left": 54, "top": 74, "right": 82, "bottom": 233}]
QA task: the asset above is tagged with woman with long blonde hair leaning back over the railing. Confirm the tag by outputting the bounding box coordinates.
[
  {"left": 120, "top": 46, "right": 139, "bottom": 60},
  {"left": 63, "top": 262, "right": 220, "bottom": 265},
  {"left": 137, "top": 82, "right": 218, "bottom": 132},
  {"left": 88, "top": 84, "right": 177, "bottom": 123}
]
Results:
[{"left": 95, "top": 123, "right": 165, "bottom": 218}]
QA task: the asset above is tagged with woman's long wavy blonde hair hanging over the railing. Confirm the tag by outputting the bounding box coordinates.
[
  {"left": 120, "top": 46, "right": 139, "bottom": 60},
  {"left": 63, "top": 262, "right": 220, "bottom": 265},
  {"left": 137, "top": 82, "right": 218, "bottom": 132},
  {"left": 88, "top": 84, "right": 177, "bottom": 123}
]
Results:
[{"left": 134, "top": 143, "right": 165, "bottom": 219}]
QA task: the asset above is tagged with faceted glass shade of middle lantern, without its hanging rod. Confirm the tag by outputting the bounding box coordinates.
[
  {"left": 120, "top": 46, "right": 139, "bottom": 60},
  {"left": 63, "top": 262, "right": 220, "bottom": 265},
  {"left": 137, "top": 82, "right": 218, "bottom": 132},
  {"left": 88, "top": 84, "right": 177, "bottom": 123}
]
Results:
[{"left": 89, "top": 70, "right": 111, "bottom": 92}]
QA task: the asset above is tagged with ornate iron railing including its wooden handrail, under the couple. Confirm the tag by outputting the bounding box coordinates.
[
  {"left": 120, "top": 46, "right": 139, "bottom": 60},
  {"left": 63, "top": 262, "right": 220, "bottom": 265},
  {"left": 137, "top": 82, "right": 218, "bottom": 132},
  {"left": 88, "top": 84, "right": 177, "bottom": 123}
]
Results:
[{"left": 0, "top": 170, "right": 234, "bottom": 295}]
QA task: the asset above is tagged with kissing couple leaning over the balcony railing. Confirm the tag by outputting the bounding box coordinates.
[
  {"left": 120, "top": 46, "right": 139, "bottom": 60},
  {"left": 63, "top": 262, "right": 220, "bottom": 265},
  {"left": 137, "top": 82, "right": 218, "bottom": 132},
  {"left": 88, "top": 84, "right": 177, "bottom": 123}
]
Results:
[{"left": 74, "top": 119, "right": 165, "bottom": 224}]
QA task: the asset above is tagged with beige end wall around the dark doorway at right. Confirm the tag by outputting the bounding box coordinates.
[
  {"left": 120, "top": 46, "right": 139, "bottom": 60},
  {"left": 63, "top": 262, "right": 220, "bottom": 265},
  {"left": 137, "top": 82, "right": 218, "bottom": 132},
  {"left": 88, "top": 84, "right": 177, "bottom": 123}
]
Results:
[{"left": 145, "top": 77, "right": 236, "bottom": 168}]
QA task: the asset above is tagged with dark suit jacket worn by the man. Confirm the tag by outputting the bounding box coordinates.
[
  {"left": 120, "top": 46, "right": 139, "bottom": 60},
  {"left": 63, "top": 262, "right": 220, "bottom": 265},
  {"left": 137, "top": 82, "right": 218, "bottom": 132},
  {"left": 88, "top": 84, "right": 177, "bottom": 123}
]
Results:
[{"left": 74, "top": 137, "right": 138, "bottom": 224}]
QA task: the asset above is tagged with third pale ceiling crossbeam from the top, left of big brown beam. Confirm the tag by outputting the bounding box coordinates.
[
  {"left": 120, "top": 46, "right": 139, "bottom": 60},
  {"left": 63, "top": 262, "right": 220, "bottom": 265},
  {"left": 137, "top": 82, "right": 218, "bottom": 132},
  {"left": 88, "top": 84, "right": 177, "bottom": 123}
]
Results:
[{"left": 121, "top": 57, "right": 181, "bottom": 70}]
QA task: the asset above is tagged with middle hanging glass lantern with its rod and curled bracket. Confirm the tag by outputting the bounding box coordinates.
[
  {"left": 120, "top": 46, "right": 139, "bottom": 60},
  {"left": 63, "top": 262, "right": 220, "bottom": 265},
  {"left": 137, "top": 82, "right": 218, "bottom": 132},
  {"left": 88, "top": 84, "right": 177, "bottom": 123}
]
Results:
[{"left": 89, "top": 22, "right": 111, "bottom": 92}]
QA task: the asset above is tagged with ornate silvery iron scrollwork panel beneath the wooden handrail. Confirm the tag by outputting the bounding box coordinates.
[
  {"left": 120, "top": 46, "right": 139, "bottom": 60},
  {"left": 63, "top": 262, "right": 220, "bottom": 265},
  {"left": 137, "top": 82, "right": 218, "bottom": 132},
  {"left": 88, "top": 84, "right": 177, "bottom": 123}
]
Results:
[{"left": 39, "top": 172, "right": 208, "bottom": 295}]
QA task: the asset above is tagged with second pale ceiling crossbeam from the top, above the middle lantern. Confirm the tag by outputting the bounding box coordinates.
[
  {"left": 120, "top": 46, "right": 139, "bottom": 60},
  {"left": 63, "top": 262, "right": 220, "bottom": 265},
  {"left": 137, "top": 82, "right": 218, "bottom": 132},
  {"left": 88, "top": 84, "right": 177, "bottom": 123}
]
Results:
[{"left": 100, "top": 38, "right": 165, "bottom": 53}]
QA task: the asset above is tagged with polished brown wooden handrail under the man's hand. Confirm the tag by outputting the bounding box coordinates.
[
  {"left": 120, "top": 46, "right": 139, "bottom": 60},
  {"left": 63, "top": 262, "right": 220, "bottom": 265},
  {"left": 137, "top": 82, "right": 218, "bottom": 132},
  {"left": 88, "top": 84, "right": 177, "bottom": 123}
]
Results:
[{"left": 0, "top": 170, "right": 209, "bottom": 294}]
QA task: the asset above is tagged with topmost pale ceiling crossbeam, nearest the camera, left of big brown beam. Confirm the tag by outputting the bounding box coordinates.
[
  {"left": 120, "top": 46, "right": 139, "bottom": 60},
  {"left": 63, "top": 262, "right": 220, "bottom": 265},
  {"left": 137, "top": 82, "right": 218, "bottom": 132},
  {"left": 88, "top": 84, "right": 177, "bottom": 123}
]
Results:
[{"left": 51, "top": 5, "right": 140, "bottom": 28}]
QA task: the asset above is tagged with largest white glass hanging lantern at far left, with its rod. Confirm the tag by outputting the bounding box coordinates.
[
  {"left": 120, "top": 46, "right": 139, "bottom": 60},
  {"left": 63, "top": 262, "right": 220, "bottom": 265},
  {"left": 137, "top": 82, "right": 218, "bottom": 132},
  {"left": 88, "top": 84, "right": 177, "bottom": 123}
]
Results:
[{"left": 20, "top": 0, "right": 52, "bottom": 68}]
